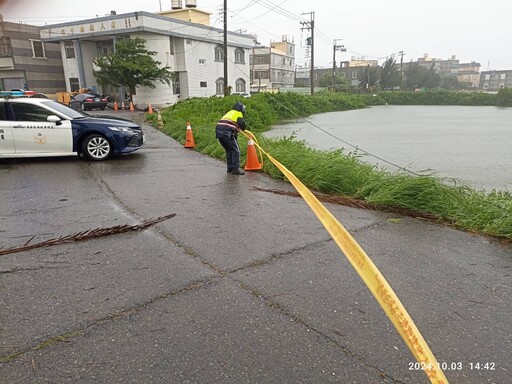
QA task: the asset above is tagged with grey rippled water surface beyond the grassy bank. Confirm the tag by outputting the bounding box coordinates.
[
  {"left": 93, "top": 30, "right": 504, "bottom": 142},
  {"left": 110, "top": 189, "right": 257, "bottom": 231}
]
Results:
[{"left": 265, "top": 105, "right": 512, "bottom": 191}]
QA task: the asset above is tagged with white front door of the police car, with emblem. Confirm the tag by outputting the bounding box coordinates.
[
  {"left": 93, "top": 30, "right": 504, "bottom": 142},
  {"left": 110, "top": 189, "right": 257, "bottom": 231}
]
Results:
[{"left": 11, "top": 102, "right": 73, "bottom": 154}]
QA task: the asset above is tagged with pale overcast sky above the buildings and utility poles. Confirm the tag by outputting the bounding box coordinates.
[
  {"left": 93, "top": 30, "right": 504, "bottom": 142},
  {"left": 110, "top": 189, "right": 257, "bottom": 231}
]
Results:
[{"left": 0, "top": 0, "right": 512, "bottom": 70}]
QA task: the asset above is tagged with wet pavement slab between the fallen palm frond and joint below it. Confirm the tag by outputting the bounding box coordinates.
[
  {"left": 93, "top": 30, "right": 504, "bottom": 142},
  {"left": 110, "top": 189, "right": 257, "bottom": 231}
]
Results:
[{"left": 0, "top": 231, "right": 217, "bottom": 356}]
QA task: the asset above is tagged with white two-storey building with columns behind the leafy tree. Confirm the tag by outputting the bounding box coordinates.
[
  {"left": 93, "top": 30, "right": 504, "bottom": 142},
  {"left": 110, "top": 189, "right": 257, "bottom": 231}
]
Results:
[{"left": 40, "top": 9, "right": 253, "bottom": 107}]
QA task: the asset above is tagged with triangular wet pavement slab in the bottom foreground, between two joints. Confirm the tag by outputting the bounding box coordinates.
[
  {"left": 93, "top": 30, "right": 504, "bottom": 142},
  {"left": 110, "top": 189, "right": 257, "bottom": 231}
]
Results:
[{"left": 3, "top": 278, "right": 394, "bottom": 384}]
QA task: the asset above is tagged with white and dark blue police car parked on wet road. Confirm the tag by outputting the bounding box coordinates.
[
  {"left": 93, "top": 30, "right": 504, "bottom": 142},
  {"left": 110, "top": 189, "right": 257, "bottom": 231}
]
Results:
[{"left": 0, "top": 92, "right": 144, "bottom": 161}]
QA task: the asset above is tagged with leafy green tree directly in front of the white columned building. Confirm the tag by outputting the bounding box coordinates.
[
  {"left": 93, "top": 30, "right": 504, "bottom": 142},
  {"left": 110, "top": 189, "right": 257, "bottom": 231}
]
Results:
[{"left": 93, "top": 38, "right": 175, "bottom": 100}]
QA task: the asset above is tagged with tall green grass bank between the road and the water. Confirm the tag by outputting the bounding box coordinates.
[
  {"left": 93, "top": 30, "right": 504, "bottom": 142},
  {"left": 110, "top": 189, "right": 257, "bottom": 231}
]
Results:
[{"left": 151, "top": 93, "right": 512, "bottom": 239}]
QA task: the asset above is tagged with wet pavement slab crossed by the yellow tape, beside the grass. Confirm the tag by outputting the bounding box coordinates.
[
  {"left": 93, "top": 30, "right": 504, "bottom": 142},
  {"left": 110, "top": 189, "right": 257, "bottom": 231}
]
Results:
[{"left": 233, "top": 218, "right": 512, "bottom": 383}]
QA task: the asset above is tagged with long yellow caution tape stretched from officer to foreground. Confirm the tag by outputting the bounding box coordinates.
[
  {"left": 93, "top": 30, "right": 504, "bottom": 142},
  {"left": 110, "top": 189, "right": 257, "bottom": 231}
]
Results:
[{"left": 242, "top": 131, "right": 448, "bottom": 384}]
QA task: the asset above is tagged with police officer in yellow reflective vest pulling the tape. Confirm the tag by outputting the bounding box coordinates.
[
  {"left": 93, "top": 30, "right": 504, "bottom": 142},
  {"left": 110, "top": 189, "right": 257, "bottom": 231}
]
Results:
[{"left": 215, "top": 101, "right": 247, "bottom": 175}]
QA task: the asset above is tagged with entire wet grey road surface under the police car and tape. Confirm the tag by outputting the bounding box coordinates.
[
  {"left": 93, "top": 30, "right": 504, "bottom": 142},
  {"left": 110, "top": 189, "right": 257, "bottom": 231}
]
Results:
[{"left": 0, "top": 112, "right": 512, "bottom": 384}]
